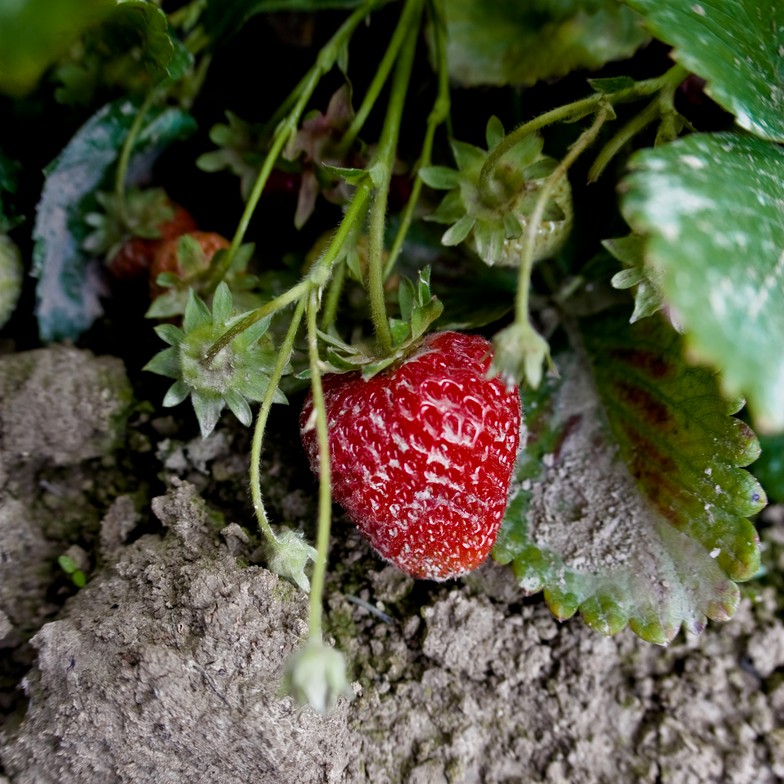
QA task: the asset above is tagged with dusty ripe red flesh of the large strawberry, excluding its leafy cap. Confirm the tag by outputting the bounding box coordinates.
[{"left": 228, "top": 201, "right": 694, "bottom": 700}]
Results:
[{"left": 300, "top": 332, "right": 522, "bottom": 580}]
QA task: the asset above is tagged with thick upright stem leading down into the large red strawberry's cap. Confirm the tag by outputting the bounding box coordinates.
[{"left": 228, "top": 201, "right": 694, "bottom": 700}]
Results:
[{"left": 368, "top": 0, "right": 422, "bottom": 356}]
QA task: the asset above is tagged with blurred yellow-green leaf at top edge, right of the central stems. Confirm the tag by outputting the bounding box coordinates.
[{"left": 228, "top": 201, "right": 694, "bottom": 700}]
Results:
[{"left": 444, "top": 0, "right": 646, "bottom": 87}]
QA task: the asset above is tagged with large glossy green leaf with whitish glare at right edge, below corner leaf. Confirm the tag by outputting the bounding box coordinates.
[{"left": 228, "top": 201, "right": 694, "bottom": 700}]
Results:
[{"left": 622, "top": 133, "right": 784, "bottom": 430}]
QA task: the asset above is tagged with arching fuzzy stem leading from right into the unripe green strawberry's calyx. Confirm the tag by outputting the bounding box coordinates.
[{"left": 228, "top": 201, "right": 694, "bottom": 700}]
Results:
[{"left": 479, "top": 65, "right": 688, "bottom": 201}]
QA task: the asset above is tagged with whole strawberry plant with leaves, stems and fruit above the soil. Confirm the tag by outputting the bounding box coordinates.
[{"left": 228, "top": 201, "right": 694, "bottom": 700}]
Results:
[{"left": 0, "top": 0, "right": 784, "bottom": 710}]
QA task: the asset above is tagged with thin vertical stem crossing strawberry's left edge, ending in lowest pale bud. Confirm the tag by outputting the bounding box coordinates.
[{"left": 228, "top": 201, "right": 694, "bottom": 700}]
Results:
[{"left": 307, "top": 289, "right": 332, "bottom": 641}]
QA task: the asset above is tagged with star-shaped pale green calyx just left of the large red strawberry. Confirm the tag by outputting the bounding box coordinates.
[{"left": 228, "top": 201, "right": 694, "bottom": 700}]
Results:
[{"left": 144, "top": 283, "right": 286, "bottom": 438}]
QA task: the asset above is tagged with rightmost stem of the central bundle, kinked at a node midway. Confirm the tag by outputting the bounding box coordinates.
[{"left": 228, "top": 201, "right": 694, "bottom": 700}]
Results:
[{"left": 384, "top": 0, "right": 450, "bottom": 279}]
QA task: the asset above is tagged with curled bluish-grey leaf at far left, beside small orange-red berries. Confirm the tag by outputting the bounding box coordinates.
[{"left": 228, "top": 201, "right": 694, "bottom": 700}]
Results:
[{"left": 33, "top": 99, "right": 195, "bottom": 342}]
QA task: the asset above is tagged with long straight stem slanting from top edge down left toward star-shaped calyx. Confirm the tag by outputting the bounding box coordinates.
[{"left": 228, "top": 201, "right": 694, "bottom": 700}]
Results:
[{"left": 208, "top": 0, "right": 381, "bottom": 291}]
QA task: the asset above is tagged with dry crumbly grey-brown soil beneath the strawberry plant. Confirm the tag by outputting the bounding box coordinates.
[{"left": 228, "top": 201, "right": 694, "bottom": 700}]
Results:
[{"left": 0, "top": 348, "right": 784, "bottom": 784}]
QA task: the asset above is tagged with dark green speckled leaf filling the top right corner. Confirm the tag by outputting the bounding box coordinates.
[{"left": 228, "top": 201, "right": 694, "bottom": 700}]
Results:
[{"left": 627, "top": 0, "right": 784, "bottom": 142}]
